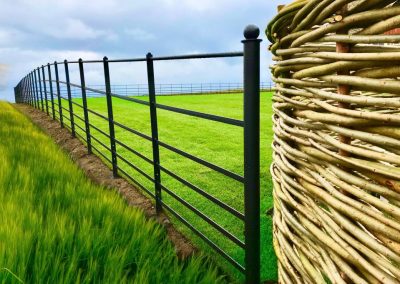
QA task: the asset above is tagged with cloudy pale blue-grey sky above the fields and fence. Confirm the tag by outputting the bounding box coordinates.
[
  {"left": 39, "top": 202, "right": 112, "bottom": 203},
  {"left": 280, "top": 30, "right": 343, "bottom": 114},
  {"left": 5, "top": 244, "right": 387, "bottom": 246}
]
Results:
[{"left": 0, "top": 0, "right": 290, "bottom": 101}]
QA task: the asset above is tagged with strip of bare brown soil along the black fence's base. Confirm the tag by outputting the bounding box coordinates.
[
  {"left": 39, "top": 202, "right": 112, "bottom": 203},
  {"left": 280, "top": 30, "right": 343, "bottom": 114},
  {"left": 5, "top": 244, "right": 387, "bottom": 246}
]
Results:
[{"left": 14, "top": 104, "right": 198, "bottom": 260}]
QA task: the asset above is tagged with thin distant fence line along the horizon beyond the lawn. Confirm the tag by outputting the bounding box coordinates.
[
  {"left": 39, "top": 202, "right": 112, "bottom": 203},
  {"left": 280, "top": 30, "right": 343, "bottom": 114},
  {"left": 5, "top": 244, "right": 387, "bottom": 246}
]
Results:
[{"left": 61, "top": 82, "right": 273, "bottom": 98}]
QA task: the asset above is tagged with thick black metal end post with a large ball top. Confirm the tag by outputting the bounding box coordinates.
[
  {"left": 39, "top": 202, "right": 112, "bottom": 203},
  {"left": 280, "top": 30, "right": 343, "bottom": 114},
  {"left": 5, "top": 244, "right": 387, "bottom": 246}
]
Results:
[{"left": 242, "top": 25, "right": 261, "bottom": 284}]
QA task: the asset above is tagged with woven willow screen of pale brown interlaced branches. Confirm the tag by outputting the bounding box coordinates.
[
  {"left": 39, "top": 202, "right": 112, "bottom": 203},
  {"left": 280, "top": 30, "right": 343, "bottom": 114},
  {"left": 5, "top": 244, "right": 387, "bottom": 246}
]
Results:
[{"left": 266, "top": 0, "right": 400, "bottom": 283}]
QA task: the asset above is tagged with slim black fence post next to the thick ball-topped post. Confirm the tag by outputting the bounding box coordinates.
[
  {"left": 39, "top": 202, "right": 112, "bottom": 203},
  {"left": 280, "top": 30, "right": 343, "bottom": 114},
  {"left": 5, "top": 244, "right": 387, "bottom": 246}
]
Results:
[{"left": 146, "top": 52, "right": 162, "bottom": 213}]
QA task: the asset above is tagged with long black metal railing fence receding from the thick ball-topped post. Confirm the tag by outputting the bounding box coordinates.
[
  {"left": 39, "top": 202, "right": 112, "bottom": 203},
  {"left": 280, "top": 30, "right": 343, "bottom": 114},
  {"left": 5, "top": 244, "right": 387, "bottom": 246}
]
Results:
[{"left": 14, "top": 25, "right": 261, "bottom": 283}]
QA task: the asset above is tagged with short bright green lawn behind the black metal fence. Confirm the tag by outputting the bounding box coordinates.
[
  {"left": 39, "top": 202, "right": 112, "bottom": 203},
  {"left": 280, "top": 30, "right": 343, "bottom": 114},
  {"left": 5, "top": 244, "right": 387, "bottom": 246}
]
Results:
[{"left": 58, "top": 93, "right": 277, "bottom": 280}]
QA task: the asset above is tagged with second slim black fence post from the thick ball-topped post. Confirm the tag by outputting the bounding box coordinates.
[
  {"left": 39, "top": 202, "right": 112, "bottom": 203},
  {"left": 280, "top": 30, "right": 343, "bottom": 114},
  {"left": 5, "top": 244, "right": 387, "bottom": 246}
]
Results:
[{"left": 103, "top": 56, "right": 118, "bottom": 177}]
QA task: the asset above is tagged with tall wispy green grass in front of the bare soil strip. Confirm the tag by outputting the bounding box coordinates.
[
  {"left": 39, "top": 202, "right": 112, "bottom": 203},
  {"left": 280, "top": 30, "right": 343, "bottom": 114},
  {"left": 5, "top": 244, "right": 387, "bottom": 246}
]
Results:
[{"left": 0, "top": 102, "right": 224, "bottom": 283}]
